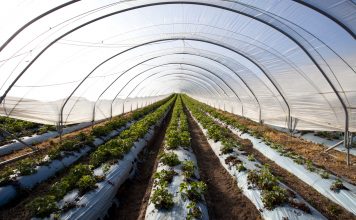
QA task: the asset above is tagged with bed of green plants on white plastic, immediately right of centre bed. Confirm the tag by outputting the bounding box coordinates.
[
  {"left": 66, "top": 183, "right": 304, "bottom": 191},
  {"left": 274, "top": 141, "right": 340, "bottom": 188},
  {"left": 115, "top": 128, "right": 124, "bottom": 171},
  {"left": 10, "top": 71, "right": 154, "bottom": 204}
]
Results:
[{"left": 183, "top": 96, "right": 323, "bottom": 219}]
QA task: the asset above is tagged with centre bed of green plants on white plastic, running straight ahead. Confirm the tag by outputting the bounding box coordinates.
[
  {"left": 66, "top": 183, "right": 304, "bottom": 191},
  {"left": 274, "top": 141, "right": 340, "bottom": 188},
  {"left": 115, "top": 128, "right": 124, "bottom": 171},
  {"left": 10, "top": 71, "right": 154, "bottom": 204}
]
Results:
[{"left": 146, "top": 96, "right": 208, "bottom": 219}]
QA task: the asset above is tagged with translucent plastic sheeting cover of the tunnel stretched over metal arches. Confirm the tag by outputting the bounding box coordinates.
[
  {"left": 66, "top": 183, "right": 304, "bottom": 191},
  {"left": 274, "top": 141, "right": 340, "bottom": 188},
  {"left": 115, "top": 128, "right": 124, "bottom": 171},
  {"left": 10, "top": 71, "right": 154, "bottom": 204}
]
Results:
[{"left": 0, "top": 0, "right": 356, "bottom": 131}]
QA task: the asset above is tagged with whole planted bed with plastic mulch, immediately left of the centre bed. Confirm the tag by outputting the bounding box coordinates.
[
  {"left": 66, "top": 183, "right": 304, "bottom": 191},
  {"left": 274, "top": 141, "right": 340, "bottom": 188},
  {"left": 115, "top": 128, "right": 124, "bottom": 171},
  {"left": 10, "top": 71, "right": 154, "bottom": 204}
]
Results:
[{"left": 27, "top": 95, "right": 173, "bottom": 219}]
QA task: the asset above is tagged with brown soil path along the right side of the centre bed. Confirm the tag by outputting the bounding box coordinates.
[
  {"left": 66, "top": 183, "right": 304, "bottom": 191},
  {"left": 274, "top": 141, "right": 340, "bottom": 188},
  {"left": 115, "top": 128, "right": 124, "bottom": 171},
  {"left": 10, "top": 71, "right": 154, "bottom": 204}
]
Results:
[{"left": 186, "top": 107, "right": 262, "bottom": 220}]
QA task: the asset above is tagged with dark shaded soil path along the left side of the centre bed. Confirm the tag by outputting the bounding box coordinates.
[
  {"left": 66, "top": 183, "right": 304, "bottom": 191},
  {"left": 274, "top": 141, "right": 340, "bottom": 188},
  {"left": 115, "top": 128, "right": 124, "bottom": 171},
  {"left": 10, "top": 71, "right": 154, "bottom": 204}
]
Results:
[{"left": 107, "top": 108, "right": 172, "bottom": 220}]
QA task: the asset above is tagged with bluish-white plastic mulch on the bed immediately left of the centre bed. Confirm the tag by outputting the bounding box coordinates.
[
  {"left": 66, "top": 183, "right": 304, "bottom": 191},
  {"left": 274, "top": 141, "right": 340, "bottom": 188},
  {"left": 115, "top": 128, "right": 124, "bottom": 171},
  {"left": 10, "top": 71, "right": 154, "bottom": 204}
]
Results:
[{"left": 58, "top": 110, "right": 169, "bottom": 220}]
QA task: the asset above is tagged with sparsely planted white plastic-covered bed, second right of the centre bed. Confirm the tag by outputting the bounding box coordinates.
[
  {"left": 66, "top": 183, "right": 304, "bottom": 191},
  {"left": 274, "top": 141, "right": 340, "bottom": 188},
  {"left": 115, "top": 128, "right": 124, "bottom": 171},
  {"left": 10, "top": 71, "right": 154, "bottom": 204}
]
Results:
[{"left": 200, "top": 102, "right": 356, "bottom": 215}]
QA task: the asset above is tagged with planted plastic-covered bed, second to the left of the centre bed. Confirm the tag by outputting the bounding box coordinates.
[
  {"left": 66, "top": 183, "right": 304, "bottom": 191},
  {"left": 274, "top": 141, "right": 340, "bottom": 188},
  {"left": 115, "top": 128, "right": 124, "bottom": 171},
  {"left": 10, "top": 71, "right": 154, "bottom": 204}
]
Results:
[{"left": 0, "top": 95, "right": 174, "bottom": 209}]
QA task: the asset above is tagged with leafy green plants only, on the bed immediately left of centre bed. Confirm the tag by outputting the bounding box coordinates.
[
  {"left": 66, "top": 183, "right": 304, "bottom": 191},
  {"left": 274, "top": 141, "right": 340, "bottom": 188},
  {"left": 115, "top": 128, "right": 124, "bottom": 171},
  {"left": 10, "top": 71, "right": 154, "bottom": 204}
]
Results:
[{"left": 27, "top": 98, "right": 174, "bottom": 217}]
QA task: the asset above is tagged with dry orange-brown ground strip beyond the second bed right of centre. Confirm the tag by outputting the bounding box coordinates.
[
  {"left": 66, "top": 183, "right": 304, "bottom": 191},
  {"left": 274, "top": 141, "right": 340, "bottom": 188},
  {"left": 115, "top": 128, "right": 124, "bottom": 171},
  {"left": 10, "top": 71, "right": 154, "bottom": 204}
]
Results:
[{"left": 217, "top": 110, "right": 356, "bottom": 185}]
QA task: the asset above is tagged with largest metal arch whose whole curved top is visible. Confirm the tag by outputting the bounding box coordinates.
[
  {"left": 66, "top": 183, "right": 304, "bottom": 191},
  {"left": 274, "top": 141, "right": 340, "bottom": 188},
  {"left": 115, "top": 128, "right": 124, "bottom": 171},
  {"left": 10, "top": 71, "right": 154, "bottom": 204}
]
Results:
[{"left": 0, "top": 1, "right": 349, "bottom": 164}]
